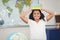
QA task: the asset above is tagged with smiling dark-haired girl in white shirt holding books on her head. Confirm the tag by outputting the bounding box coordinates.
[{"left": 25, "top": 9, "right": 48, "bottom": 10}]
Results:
[{"left": 20, "top": 8, "right": 54, "bottom": 40}]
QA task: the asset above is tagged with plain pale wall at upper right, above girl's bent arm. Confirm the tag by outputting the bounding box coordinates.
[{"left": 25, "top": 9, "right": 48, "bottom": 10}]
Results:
[{"left": 41, "top": 0, "right": 60, "bottom": 14}]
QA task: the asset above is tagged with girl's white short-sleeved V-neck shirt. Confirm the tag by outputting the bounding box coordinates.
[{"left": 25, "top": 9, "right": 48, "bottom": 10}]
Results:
[{"left": 28, "top": 19, "right": 46, "bottom": 40}]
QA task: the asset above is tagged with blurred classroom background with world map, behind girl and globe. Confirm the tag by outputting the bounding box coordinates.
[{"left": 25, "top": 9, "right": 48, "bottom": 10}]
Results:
[{"left": 0, "top": 0, "right": 60, "bottom": 40}]
